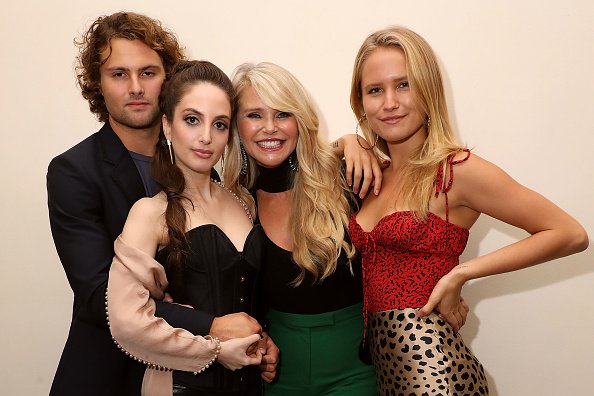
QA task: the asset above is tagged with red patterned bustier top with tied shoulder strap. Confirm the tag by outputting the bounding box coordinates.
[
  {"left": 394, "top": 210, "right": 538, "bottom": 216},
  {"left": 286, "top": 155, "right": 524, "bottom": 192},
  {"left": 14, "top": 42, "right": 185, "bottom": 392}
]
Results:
[{"left": 349, "top": 151, "right": 470, "bottom": 317}]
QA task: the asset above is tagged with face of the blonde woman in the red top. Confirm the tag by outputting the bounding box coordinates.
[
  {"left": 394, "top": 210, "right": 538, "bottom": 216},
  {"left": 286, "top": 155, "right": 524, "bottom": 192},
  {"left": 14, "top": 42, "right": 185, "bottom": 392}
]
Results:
[{"left": 361, "top": 47, "right": 427, "bottom": 147}]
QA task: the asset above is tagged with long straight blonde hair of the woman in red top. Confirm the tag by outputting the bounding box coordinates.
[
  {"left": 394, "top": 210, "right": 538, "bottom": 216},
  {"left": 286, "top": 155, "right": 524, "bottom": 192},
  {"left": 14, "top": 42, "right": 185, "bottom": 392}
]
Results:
[{"left": 351, "top": 26, "right": 464, "bottom": 219}]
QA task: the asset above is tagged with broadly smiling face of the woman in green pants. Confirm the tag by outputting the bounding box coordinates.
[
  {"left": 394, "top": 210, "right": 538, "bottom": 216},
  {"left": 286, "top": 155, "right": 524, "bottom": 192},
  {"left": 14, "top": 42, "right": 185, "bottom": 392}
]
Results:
[{"left": 232, "top": 86, "right": 299, "bottom": 168}]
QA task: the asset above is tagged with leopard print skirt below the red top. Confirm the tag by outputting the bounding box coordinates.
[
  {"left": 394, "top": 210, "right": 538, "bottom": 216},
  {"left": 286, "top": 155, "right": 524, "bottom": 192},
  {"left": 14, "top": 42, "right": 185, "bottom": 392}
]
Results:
[{"left": 367, "top": 308, "right": 489, "bottom": 396}]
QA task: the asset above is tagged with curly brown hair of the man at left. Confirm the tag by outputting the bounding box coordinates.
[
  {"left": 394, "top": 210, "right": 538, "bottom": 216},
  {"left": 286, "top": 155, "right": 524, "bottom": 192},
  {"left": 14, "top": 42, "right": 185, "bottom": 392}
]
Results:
[{"left": 74, "top": 12, "right": 185, "bottom": 122}]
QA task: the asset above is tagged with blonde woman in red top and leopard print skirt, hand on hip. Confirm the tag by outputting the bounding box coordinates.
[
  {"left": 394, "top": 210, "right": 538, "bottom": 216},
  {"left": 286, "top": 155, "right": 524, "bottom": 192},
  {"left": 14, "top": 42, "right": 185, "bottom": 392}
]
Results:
[{"left": 349, "top": 27, "right": 588, "bottom": 395}]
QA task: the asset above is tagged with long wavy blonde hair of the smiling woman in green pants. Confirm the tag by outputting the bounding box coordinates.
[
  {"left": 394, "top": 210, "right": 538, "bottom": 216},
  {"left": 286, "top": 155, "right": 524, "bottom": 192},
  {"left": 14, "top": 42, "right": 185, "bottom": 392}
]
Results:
[{"left": 224, "top": 62, "right": 355, "bottom": 285}]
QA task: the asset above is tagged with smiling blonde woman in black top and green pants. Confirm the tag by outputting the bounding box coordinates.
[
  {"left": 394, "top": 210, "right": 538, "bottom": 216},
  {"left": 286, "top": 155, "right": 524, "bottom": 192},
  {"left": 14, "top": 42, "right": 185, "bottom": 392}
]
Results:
[{"left": 224, "top": 63, "right": 376, "bottom": 396}]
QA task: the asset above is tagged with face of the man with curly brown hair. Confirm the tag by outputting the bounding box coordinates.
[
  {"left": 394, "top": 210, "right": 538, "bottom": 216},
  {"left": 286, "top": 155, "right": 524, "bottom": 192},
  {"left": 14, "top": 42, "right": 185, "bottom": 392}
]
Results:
[{"left": 100, "top": 38, "right": 165, "bottom": 129}]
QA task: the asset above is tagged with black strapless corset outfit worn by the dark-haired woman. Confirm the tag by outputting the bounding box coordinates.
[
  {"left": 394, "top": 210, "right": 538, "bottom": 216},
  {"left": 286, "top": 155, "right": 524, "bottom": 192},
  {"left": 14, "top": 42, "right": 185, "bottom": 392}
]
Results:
[{"left": 156, "top": 224, "right": 265, "bottom": 395}]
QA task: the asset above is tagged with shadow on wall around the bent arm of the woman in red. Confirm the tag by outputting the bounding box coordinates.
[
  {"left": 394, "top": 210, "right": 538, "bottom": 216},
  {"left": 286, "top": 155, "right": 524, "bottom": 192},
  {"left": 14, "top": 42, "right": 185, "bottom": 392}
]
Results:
[{"left": 460, "top": 215, "right": 594, "bottom": 396}]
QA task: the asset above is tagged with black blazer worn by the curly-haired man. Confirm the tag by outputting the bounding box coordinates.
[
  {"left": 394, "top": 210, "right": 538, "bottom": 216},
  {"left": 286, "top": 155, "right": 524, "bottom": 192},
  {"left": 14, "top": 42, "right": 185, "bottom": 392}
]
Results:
[{"left": 47, "top": 123, "right": 213, "bottom": 396}]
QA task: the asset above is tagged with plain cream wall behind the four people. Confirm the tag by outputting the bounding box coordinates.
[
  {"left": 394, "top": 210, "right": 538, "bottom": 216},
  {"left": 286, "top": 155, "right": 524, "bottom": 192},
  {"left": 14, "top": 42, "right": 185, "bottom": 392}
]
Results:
[{"left": 0, "top": 0, "right": 594, "bottom": 396}]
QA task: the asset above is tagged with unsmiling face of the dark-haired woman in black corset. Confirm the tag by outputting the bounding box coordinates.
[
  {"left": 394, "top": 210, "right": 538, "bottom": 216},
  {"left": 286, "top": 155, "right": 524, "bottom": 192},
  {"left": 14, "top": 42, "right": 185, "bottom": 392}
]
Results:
[{"left": 163, "top": 82, "right": 231, "bottom": 174}]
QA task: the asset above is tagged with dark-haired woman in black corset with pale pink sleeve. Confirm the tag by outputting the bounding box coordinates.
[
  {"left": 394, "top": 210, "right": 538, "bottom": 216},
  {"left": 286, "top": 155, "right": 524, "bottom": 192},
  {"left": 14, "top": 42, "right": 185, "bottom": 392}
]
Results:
[{"left": 106, "top": 61, "right": 267, "bottom": 396}]
